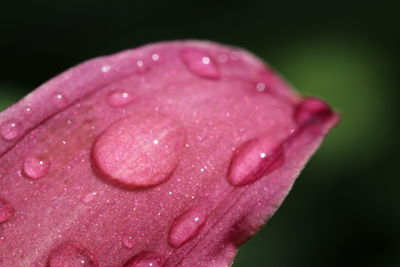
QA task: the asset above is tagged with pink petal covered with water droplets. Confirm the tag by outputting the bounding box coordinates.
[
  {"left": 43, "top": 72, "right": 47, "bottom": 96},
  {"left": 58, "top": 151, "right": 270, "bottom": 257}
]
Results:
[{"left": 0, "top": 41, "right": 338, "bottom": 267}]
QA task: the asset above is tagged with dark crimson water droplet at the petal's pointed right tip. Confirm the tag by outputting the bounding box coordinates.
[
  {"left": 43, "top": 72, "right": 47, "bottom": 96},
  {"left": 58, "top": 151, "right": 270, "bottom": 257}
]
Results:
[{"left": 294, "top": 98, "right": 333, "bottom": 125}]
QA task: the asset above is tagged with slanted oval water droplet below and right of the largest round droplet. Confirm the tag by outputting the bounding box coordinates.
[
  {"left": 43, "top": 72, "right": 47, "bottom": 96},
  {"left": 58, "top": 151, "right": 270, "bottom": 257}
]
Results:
[{"left": 168, "top": 208, "right": 207, "bottom": 248}]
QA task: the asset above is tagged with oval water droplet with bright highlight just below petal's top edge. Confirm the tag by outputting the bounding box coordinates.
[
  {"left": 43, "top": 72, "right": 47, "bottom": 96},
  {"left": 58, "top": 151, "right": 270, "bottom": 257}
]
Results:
[{"left": 182, "top": 49, "right": 220, "bottom": 79}]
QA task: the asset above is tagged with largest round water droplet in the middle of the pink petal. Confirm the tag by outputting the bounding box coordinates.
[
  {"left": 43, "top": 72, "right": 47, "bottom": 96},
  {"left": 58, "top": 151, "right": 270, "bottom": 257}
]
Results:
[{"left": 92, "top": 113, "right": 185, "bottom": 188}]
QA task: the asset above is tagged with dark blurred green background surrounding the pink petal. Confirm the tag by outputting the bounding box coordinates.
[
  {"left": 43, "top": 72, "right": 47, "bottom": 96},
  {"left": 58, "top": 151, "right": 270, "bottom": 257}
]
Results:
[{"left": 0, "top": 0, "right": 400, "bottom": 267}]
